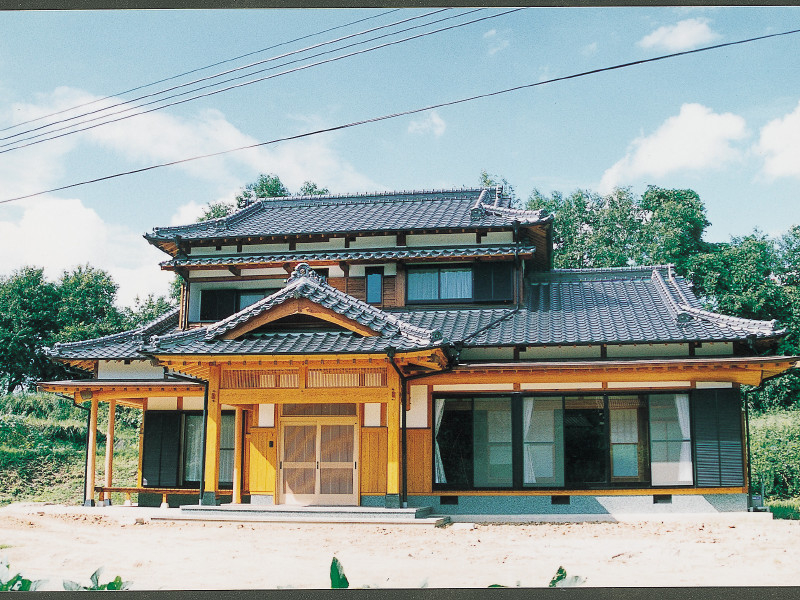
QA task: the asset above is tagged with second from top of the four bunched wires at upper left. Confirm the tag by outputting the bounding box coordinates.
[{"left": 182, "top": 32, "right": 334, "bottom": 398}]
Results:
[{"left": 0, "top": 8, "right": 450, "bottom": 147}]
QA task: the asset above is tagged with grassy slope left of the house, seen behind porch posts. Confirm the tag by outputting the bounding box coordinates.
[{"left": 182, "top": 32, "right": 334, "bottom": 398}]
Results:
[{"left": 0, "top": 394, "right": 139, "bottom": 504}]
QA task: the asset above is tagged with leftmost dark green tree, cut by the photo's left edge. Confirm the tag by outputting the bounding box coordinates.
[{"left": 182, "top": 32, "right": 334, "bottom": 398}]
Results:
[{"left": 0, "top": 267, "right": 59, "bottom": 393}]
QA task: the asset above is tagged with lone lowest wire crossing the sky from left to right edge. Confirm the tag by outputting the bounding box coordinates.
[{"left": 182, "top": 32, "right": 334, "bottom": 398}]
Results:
[{"left": 0, "top": 29, "right": 800, "bottom": 204}]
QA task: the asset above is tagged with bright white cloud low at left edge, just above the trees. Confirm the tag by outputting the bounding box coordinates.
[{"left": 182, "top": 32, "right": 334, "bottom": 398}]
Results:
[{"left": 0, "top": 196, "right": 171, "bottom": 305}]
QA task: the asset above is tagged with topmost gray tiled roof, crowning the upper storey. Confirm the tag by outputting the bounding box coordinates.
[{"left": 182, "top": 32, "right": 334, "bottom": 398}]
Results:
[{"left": 145, "top": 188, "right": 552, "bottom": 243}]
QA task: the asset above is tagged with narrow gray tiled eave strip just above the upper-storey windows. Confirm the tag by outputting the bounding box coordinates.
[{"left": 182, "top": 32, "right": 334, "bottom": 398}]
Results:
[{"left": 161, "top": 244, "right": 534, "bottom": 267}]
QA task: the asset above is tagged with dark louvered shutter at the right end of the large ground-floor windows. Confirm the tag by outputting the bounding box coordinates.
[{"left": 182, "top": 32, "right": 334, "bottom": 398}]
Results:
[{"left": 692, "top": 389, "right": 744, "bottom": 487}]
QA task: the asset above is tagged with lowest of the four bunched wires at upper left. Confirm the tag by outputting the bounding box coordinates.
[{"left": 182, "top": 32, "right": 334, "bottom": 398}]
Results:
[{"left": 0, "top": 8, "right": 506, "bottom": 154}]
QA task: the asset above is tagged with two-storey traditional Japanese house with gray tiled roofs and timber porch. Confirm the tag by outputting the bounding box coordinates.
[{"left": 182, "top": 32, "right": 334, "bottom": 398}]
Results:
[{"left": 41, "top": 187, "right": 795, "bottom": 515}]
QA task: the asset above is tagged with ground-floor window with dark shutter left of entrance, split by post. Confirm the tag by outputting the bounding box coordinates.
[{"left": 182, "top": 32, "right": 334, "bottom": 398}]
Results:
[{"left": 142, "top": 411, "right": 235, "bottom": 487}]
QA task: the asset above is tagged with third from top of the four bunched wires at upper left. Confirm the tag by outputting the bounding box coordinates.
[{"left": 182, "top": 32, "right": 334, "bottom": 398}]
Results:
[{"left": 0, "top": 8, "right": 476, "bottom": 154}]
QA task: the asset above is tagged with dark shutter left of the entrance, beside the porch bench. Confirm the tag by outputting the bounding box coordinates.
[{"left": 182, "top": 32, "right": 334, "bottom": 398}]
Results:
[{"left": 142, "top": 411, "right": 181, "bottom": 487}]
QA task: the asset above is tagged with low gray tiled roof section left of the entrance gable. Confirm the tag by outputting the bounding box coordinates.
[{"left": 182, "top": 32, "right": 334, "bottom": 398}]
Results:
[{"left": 46, "top": 307, "right": 179, "bottom": 360}]
